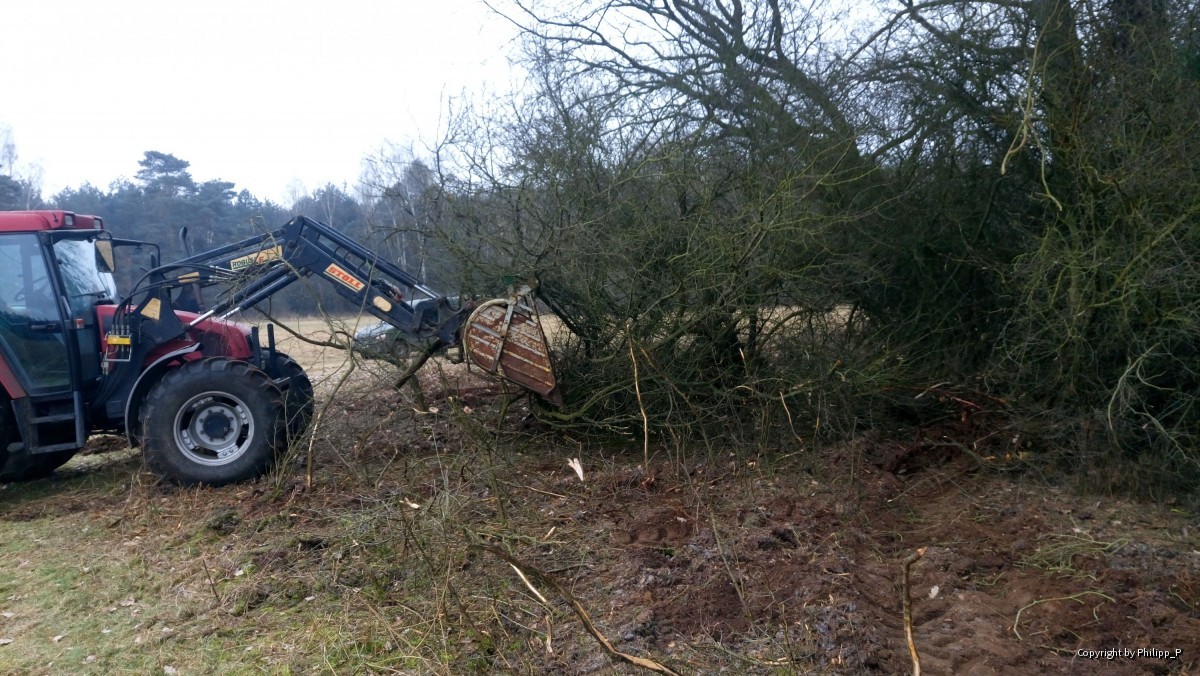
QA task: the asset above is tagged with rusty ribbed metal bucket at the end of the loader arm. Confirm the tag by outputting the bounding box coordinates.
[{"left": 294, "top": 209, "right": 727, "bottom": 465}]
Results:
[{"left": 463, "top": 289, "right": 563, "bottom": 405}]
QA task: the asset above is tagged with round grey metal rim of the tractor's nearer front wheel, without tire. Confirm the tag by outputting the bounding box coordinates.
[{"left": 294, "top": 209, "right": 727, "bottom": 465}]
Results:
[{"left": 174, "top": 391, "right": 254, "bottom": 466}]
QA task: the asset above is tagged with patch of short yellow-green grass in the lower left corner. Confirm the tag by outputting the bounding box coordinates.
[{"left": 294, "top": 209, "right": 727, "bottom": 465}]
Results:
[{"left": 0, "top": 463, "right": 436, "bottom": 674}]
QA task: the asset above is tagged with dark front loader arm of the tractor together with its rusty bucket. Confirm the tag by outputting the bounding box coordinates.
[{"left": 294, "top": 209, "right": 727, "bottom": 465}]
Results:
[{"left": 117, "top": 216, "right": 560, "bottom": 402}]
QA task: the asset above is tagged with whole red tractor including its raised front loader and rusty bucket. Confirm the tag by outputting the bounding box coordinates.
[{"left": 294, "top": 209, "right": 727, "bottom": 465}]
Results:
[{"left": 0, "top": 210, "right": 560, "bottom": 485}]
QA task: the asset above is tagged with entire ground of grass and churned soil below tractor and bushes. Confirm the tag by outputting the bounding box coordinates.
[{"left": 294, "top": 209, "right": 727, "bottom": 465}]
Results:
[{"left": 0, "top": 323, "right": 1200, "bottom": 674}]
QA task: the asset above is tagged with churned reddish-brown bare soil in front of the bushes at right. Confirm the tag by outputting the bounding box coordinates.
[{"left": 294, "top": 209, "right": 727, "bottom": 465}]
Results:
[{"left": 523, "top": 446, "right": 1200, "bottom": 674}]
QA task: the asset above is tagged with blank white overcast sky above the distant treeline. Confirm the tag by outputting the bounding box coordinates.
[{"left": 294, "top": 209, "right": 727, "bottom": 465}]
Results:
[{"left": 0, "top": 0, "right": 525, "bottom": 203}]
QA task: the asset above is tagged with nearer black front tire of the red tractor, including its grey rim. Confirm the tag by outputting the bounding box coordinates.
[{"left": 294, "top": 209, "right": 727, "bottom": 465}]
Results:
[{"left": 140, "top": 357, "right": 287, "bottom": 486}]
